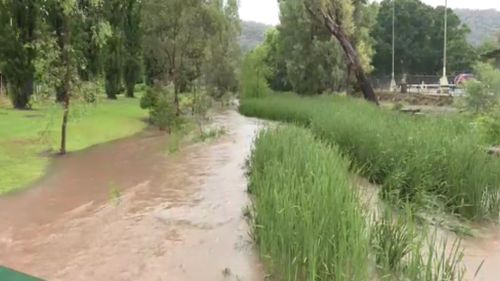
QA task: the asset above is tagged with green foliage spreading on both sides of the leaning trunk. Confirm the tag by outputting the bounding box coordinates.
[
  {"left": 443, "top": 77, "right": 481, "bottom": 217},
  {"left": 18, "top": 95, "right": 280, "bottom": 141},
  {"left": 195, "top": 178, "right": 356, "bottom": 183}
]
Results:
[{"left": 254, "top": 0, "right": 375, "bottom": 95}]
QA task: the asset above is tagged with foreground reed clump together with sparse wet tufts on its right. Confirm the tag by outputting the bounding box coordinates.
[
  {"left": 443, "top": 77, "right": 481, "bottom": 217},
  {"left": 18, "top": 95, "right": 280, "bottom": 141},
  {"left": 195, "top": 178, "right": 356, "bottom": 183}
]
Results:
[{"left": 249, "top": 127, "right": 462, "bottom": 281}]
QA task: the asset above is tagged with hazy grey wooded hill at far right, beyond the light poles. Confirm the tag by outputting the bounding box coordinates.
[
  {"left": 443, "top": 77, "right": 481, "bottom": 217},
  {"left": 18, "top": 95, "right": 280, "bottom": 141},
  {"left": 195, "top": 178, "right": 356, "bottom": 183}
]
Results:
[{"left": 455, "top": 9, "right": 500, "bottom": 46}]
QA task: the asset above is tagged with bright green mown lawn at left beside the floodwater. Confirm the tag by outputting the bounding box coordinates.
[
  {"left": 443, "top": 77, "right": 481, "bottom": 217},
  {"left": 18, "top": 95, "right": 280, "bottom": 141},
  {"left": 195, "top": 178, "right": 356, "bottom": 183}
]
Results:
[{"left": 0, "top": 97, "right": 147, "bottom": 195}]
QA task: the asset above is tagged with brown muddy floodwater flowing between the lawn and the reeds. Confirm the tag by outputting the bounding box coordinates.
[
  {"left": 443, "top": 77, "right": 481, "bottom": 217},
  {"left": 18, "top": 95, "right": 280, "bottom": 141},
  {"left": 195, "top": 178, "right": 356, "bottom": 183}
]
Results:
[{"left": 0, "top": 111, "right": 264, "bottom": 281}]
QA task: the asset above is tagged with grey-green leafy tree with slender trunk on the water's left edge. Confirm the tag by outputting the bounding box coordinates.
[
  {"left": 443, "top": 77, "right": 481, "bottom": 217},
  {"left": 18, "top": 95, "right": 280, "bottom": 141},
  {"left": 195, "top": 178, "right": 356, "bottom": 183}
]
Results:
[{"left": 142, "top": 0, "right": 209, "bottom": 114}]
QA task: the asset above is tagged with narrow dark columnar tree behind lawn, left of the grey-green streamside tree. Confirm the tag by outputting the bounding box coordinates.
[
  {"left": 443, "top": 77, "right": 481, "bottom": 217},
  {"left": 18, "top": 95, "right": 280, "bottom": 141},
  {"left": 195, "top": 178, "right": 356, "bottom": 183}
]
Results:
[{"left": 123, "top": 0, "right": 142, "bottom": 98}]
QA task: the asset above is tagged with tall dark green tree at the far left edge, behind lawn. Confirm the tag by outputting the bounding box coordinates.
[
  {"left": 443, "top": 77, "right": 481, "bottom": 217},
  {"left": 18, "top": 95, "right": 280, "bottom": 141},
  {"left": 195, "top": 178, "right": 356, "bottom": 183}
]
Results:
[{"left": 0, "top": 0, "right": 39, "bottom": 109}]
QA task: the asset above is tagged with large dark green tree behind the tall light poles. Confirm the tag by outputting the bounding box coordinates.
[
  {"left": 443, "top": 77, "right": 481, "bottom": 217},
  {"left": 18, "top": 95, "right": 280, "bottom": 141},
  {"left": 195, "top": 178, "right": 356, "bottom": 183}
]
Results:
[{"left": 372, "top": 0, "right": 477, "bottom": 75}]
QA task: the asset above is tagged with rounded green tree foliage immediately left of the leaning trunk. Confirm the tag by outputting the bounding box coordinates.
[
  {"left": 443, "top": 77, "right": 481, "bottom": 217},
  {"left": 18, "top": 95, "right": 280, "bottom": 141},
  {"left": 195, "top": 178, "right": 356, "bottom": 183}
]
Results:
[{"left": 276, "top": 0, "right": 346, "bottom": 94}]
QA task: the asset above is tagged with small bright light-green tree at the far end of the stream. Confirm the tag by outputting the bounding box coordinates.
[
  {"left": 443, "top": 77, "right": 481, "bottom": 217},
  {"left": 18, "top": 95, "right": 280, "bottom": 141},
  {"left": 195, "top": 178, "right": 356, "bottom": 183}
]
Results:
[{"left": 240, "top": 46, "right": 271, "bottom": 98}]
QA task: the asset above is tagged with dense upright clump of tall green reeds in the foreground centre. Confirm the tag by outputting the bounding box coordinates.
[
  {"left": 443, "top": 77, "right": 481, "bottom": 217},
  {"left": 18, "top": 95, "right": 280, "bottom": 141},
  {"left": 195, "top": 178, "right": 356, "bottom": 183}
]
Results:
[{"left": 249, "top": 127, "right": 370, "bottom": 281}]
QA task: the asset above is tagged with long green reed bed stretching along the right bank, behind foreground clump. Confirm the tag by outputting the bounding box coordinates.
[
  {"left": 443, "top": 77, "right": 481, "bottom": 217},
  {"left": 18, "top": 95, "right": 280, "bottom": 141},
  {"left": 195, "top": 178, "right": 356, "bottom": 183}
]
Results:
[{"left": 240, "top": 95, "right": 500, "bottom": 220}]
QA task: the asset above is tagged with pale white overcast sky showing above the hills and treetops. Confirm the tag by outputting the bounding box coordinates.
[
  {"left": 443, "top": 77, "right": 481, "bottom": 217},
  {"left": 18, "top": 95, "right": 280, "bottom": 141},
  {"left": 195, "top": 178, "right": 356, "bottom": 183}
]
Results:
[{"left": 240, "top": 0, "right": 500, "bottom": 25}]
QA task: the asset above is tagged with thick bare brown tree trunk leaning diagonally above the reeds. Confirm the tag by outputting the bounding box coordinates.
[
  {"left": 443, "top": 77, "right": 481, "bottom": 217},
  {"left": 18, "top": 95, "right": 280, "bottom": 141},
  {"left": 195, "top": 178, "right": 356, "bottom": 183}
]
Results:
[{"left": 306, "top": 6, "right": 379, "bottom": 105}]
